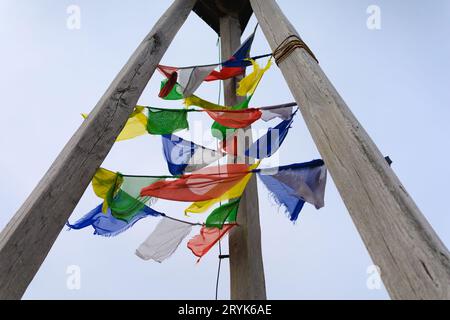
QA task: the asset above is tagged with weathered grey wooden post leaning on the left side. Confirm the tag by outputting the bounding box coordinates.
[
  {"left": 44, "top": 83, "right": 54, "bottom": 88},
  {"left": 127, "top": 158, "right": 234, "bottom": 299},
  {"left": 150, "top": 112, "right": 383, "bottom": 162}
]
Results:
[{"left": 0, "top": 0, "right": 196, "bottom": 299}]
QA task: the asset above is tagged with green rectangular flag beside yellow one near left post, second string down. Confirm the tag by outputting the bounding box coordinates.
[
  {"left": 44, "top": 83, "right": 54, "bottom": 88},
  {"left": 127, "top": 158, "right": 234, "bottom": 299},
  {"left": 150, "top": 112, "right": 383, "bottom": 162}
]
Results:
[{"left": 147, "top": 108, "right": 189, "bottom": 135}]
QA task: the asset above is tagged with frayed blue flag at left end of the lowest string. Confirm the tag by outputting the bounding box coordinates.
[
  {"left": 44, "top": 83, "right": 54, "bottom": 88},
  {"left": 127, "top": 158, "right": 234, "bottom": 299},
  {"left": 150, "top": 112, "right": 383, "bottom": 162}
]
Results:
[{"left": 67, "top": 204, "right": 161, "bottom": 237}]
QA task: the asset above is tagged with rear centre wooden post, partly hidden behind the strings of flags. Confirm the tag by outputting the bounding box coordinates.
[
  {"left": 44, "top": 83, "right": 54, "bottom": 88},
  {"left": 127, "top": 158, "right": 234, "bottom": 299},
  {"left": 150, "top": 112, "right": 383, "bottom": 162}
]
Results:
[{"left": 220, "top": 15, "right": 266, "bottom": 300}]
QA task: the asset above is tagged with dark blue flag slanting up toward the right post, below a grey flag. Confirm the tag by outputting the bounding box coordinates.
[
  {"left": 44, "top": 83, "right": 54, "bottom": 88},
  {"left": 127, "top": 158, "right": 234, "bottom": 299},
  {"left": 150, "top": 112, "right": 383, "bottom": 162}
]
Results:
[{"left": 245, "top": 113, "right": 295, "bottom": 159}]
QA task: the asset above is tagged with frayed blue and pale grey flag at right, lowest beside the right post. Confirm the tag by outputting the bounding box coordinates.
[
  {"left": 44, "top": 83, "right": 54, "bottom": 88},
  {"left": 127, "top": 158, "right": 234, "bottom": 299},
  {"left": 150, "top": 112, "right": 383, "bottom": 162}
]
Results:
[{"left": 258, "top": 160, "right": 327, "bottom": 221}]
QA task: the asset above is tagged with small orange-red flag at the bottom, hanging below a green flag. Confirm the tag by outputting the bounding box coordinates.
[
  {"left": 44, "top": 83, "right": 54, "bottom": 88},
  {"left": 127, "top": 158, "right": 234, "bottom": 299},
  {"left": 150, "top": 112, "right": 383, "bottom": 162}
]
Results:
[{"left": 188, "top": 224, "right": 236, "bottom": 261}]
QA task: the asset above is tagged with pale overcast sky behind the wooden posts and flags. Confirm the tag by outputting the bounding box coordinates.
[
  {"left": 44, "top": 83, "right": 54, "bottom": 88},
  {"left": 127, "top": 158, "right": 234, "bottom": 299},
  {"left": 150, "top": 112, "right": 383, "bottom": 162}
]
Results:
[{"left": 0, "top": 0, "right": 450, "bottom": 299}]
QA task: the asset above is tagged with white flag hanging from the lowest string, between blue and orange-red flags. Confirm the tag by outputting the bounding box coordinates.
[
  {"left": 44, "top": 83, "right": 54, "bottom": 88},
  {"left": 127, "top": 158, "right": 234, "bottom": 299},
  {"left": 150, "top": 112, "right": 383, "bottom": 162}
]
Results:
[{"left": 136, "top": 218, "right": 192, "bottom": 263}]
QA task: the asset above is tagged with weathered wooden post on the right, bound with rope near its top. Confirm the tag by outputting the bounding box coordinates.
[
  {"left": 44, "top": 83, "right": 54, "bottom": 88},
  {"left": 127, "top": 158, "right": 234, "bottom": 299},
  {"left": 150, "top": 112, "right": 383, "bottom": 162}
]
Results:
[{"left": 250, "top": 0, "right": 450, "bottom": 299}]
